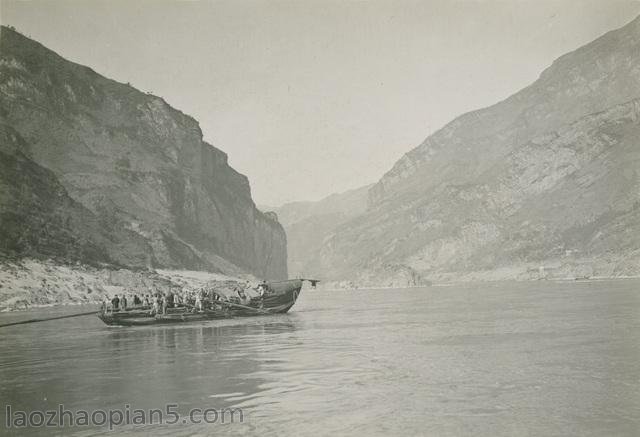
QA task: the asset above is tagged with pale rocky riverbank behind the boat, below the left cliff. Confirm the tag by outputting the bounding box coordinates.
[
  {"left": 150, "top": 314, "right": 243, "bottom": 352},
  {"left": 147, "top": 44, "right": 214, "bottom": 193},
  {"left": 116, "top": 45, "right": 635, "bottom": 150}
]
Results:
[{"left": 0, "top": 259, "right": 257, "bottom": 312}]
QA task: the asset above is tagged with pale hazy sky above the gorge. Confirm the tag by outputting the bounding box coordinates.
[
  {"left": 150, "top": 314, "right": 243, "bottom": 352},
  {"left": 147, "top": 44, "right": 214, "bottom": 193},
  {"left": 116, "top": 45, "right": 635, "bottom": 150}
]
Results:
[{"left": 0, "top": 0, "right": 640, "bottom": 205}]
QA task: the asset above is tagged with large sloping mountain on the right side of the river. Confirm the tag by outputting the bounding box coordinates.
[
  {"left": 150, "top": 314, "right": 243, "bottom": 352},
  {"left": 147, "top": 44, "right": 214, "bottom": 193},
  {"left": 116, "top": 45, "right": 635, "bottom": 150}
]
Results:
[{"left": 316, "top": 18, "right": 640, "bottom": 285}]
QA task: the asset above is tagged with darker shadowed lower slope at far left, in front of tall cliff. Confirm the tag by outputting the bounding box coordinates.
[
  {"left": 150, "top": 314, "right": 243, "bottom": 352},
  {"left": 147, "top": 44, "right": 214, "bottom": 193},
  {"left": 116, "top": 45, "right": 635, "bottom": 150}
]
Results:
[{"left": 0, "top": 125, "right": 148, "bottom": 267}]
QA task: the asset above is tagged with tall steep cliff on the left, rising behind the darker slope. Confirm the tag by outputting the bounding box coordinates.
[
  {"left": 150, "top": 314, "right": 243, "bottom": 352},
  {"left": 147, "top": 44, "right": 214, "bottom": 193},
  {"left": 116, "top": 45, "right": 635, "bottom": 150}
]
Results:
[{"left": 0, "top": 27, "right": 287, "bottom": 279}]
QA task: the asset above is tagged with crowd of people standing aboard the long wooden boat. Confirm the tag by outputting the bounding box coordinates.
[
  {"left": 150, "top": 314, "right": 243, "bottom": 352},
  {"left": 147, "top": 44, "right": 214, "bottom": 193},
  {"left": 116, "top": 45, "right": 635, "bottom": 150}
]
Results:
[{"left": 102, "top": 281, "right": 269, "bottom": 315}]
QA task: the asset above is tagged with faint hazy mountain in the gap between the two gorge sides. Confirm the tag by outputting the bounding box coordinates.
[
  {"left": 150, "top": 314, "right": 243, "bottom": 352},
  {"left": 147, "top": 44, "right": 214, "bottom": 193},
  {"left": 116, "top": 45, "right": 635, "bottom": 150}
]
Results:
[{"left": 263, "top": 185, "right": 371, "bottom": 277}]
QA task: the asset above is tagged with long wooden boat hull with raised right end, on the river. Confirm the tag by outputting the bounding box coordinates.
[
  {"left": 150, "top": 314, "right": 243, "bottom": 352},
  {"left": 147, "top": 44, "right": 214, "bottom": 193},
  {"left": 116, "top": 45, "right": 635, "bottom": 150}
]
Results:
[{"left": 98, "top": 279, "right": 310, "bottom": 326}]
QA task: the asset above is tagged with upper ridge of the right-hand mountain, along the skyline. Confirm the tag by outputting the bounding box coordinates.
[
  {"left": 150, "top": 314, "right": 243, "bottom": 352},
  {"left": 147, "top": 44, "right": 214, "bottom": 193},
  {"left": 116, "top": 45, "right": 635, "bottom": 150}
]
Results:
[{"left": 370, "top": 13, "right": 640, "bottom": 205}]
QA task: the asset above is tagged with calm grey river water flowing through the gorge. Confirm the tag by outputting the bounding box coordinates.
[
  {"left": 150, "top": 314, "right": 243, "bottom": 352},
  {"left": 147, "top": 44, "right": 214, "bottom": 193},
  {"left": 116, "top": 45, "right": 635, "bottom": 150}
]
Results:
[{"left": 0, "top": 280, "right": 640, "bottom": 436}]
